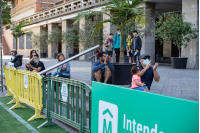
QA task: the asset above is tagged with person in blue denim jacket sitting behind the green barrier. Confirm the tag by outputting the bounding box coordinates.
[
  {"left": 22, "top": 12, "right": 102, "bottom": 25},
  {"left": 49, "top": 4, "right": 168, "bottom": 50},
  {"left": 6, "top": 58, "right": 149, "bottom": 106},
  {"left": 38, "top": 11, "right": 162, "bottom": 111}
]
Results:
[{"left": 52, "top": 53, "right": 71, "bottom": 79}]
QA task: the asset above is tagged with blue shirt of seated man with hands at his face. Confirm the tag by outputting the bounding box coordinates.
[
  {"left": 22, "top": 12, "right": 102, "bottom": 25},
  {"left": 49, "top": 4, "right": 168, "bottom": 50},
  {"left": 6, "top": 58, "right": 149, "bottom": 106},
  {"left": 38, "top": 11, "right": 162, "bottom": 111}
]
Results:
[{"left": 92, "top": 60, "right": 114, "bottom": 75}]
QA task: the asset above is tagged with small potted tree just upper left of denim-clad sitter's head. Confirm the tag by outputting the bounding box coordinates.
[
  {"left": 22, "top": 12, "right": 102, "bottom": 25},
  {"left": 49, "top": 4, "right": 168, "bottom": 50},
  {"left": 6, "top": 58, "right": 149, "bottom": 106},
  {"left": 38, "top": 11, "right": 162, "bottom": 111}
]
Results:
[{"left": 46, "top": 27, "right": 63, "bottom": 59}]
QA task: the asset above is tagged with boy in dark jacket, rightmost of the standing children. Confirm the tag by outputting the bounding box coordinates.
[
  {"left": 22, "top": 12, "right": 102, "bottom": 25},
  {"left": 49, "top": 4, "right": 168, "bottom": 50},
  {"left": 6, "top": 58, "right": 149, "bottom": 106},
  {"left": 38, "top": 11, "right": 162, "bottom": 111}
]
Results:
[{"left": 131, "top": 30, "right": 142, "bottom": 65}]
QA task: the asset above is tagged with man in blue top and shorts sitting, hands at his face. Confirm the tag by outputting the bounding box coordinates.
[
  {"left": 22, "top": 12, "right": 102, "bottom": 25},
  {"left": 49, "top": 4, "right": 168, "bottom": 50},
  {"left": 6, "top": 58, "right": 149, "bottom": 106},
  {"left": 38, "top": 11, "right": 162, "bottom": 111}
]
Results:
[{"left": 92, "top": 52, "right": 114, "bottom": 84}]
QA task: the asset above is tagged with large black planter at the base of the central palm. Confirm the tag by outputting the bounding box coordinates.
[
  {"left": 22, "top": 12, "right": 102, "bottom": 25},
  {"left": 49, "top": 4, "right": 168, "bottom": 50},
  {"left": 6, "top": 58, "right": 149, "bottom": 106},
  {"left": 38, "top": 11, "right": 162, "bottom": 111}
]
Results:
[{"left": 112, "top": 63, "right": 136, "bottom": 85}]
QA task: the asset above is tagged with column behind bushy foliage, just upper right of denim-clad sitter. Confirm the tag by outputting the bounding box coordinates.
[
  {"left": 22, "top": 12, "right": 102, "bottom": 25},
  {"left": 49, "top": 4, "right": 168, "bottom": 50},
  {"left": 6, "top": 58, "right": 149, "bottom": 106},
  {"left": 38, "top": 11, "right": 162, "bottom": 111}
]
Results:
[{"left": 62, "top": 20, "right": 73, "bottom": 58}]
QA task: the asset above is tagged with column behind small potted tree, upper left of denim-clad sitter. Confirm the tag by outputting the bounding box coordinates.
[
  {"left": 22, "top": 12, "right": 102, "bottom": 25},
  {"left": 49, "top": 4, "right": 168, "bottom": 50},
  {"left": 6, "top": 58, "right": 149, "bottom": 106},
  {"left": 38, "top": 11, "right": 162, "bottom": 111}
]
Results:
[{"left": 48, "top": 23, "right": 56, "bottom": 58}]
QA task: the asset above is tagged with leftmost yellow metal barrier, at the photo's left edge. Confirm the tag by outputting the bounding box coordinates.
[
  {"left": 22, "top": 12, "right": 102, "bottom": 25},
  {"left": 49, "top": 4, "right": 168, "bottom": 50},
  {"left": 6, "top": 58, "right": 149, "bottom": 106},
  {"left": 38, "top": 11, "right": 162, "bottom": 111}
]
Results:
[{"left": 4, "top": 66, "right": 16, "bottom": 104}]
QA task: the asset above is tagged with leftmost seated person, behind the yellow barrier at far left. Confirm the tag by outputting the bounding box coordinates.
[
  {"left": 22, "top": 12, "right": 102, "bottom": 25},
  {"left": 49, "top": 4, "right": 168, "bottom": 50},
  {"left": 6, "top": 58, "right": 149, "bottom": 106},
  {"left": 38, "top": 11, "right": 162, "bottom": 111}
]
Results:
[{"left": 5, "top": 51, "right": 23, "bottom": 68}]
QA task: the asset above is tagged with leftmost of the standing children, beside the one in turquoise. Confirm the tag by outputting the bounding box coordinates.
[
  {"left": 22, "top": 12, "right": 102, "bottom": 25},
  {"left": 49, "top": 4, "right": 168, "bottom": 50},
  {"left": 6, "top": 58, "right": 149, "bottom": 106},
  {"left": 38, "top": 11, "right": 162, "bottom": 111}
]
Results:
[{"left": 105, "top": 33, "right": 113, "bottom": 61}]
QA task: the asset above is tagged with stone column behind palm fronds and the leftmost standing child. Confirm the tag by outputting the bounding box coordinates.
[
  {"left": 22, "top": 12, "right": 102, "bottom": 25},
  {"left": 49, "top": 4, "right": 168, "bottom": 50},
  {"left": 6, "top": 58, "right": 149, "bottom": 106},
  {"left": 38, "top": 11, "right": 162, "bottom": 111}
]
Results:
[{"left": 103, "top": 10, "right": 116, "bottom": 63}]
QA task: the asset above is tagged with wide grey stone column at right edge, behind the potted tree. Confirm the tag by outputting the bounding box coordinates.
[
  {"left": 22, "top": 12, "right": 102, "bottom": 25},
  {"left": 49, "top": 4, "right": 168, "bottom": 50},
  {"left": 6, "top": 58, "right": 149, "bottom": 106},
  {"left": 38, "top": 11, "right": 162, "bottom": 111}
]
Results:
[{"left": 181, "top": 0, "right": 199, "bottom": 68}]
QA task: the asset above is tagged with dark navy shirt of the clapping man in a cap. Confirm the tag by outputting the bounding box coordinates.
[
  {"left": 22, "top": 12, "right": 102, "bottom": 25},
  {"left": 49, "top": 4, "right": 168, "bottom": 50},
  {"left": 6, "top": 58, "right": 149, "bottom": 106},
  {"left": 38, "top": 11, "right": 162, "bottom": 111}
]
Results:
[{"left": 141, "top": 66, "right": 154, "bottom": 90}]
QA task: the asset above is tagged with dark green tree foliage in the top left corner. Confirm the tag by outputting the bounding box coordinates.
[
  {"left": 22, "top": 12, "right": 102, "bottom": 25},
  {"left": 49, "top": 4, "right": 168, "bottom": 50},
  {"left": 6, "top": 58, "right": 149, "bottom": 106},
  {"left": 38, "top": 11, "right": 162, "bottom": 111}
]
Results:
[{"left": 1, "top": 1, "right": 11, "bottom": 25}]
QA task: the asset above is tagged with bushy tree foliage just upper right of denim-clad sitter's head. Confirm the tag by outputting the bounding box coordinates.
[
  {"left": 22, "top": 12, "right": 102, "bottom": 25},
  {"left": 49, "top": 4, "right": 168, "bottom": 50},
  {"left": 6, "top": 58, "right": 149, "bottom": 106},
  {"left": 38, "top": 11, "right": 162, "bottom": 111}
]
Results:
[{"left": 62, "top": 27, "right": 79, "bottom": 48}]
